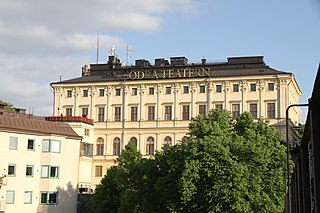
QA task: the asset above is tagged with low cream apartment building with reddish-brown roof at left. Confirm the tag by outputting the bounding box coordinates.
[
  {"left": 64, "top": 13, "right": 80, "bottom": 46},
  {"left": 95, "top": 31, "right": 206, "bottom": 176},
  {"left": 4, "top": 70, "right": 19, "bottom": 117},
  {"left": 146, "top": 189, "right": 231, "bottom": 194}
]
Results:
[{"left": 0, "top": 111, "right": 82, "bottom": 213}]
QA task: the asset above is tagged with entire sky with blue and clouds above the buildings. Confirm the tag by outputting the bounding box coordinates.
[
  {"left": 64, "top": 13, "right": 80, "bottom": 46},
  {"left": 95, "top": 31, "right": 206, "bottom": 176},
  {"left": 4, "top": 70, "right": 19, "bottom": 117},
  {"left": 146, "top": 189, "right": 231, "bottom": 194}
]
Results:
[{"left": 0, "top": 0, "right": 320, "bottom": 122}]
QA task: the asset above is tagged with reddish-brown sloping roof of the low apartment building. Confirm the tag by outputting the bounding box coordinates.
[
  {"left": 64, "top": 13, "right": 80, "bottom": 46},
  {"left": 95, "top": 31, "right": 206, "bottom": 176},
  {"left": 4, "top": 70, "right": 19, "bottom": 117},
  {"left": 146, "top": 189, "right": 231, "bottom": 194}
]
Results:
[{"left": 0, "top": 115, "right": 82, "bottom": 139}]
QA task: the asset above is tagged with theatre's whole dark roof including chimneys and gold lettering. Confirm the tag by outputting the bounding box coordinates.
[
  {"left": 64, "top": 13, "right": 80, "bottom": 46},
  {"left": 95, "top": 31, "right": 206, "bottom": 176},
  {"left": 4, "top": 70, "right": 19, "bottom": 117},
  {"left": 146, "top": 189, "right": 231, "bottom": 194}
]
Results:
[{"left": 52, "top": 56, "right": 291, "bottom": 84}]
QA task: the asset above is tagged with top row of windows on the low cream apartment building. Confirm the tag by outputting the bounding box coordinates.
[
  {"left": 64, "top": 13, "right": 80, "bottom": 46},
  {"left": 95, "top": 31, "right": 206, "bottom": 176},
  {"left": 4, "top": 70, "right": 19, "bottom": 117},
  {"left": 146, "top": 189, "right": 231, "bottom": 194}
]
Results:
[{"left": 9, "top": 137, "right": 61, "bottom": 153}]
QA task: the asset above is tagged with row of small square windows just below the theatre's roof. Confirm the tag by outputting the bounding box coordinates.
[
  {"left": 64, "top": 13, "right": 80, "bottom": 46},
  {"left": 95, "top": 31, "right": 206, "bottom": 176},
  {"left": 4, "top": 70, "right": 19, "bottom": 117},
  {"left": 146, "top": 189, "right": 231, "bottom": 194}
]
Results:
[{"left": 67, "top": 83, "right": 274, "bottom": 98}]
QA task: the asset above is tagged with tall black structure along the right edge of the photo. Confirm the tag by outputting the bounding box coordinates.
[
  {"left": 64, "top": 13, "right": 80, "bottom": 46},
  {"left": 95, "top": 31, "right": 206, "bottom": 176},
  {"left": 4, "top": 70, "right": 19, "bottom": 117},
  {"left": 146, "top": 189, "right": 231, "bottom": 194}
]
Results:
[{"left": 286, "top": 65, "right": 320, "bottom": 213}]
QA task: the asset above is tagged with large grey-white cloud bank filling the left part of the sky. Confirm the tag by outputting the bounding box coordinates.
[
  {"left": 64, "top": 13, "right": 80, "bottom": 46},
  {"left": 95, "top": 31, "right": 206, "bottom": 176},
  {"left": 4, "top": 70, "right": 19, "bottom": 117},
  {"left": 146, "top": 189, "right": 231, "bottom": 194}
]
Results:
[{"left": 0, "top": 0, "right": 192, "bottom": 115}]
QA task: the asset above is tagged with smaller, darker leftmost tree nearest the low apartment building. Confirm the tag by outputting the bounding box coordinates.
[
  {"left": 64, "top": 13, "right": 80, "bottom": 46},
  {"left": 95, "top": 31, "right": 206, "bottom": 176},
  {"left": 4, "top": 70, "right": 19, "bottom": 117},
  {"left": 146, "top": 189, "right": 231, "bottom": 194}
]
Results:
[{"left": 89, "top": 143, "right": 158, "bottom": 213}]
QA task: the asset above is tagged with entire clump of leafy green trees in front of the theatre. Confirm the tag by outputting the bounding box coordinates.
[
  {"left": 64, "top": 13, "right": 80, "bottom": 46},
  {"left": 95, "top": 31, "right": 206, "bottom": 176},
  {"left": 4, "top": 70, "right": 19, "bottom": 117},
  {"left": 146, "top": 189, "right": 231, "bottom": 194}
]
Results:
[{"left": 90, "top": 110, "right": 286, "bottom": 213}]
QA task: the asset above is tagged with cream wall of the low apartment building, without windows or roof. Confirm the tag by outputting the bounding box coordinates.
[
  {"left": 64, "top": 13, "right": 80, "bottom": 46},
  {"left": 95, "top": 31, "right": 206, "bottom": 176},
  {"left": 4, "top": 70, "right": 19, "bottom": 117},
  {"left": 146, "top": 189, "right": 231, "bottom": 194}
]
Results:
[{"left": 0, "top": 131, "right": 80, "bottom": 213}]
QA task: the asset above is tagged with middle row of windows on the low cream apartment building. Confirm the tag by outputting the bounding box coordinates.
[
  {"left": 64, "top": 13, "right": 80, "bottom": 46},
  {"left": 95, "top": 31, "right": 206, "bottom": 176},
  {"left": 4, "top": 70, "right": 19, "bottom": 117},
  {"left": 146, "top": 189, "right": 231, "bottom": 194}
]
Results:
[{"left": 8, "top": 163, "right": 59, "bottom": 178}]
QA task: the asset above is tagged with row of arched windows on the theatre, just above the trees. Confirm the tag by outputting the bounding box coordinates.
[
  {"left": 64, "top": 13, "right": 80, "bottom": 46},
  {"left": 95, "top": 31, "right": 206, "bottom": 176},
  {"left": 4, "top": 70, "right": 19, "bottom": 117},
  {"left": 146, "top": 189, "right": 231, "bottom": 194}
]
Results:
[{"left": 80, "top": 136, "right": 187, "bottom": 156}]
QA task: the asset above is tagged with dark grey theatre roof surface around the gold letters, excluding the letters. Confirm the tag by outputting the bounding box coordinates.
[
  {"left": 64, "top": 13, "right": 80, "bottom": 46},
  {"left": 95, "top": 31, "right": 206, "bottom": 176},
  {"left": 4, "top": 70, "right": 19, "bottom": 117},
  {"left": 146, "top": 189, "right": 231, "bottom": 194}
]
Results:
[{"left": 52, "top": 56, "right": 291, "bottom": 84}]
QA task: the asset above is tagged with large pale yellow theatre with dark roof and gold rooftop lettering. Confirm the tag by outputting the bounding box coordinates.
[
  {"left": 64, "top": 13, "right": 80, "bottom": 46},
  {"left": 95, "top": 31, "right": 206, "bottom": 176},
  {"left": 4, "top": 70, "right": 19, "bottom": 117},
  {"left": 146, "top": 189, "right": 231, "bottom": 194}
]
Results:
[{"left": 51, "top": 56, "right": 301, "bottom": 185}]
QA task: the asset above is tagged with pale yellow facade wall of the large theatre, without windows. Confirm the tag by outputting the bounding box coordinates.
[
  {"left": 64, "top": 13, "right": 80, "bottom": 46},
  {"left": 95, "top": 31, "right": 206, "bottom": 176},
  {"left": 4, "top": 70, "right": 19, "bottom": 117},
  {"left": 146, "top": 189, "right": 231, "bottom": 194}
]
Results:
[{"left": 53, "top": 70, "right": 301, "bottom": 184}]
